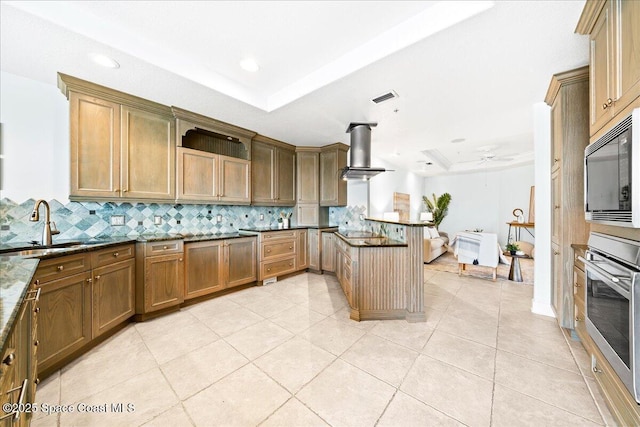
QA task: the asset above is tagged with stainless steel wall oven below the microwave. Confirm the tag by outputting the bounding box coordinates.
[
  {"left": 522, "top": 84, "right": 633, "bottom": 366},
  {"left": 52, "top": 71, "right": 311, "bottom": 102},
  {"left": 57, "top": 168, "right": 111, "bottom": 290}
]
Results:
[{"left": 582, "top": 232, "right": 640, "bottom": 403}]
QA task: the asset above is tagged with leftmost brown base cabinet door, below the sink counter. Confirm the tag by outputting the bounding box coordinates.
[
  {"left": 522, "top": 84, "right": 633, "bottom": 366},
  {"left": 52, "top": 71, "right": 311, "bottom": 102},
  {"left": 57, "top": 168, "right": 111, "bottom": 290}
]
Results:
[{"left": 38, "top": 272, "right": 91, "bottom": 372}]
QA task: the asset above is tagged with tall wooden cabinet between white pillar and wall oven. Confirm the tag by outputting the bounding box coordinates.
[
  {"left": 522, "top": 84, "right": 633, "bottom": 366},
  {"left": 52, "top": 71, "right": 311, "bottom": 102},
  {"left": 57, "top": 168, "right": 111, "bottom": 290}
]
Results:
[{"left": 545, "top": 67, "right": 589, "bottom": 329}]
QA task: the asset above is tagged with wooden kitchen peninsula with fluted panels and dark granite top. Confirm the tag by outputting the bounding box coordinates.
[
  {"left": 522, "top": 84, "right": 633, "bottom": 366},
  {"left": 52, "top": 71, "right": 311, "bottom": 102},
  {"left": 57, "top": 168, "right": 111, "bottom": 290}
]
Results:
[{"left": 335, "top": 219, "right": 426, "bottom": 322}]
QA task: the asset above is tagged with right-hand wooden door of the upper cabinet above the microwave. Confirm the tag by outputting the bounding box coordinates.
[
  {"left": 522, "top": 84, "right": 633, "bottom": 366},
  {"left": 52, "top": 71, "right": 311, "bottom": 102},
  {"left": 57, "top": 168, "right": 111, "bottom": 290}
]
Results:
[{"left": 615, "top": 0, "right": 640, "bottom": 112}]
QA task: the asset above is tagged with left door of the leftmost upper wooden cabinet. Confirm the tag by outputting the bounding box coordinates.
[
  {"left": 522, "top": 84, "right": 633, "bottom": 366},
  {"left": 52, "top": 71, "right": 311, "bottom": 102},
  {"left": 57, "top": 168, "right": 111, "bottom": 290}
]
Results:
[{"left": 69, "top": 92, "right": 120, "bottom": 198}]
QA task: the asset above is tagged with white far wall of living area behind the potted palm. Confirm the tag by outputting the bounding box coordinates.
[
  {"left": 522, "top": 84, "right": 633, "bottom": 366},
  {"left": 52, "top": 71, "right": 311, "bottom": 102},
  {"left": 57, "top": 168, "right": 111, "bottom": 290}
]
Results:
[{"left": 424, "top": 164, "right": 535, "bottom": 246}]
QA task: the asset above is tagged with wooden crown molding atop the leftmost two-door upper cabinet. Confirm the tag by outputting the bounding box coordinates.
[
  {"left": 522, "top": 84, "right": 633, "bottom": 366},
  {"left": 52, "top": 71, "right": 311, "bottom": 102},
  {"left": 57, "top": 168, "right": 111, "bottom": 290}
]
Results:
[{"left": 58, "top": 73, "right": 173, "bottom": 119}]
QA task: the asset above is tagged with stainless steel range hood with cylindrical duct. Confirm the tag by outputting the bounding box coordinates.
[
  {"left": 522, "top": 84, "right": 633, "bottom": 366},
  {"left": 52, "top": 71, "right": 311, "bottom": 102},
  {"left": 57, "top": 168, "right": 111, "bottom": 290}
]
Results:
[{"left": 340, "top": 123, "right": 385, "bottom": 181}]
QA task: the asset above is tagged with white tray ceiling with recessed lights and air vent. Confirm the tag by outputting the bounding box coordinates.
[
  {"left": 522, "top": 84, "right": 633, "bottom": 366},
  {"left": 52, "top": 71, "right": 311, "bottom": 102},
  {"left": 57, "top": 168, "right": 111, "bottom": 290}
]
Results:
[{"left": 0, "top": 0, "right": 588, "bottom": 175}]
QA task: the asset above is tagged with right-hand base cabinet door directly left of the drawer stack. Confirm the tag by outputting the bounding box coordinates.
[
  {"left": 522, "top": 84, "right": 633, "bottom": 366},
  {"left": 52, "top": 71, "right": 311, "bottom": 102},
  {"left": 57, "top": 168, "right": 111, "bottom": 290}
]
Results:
[{"left": 225, "top": 237, "right": 257, "bottom": 288}]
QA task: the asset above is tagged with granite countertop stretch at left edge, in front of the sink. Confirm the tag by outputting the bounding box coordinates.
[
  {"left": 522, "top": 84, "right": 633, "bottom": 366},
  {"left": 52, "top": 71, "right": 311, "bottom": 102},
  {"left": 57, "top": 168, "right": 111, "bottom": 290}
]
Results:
[{"left": 0, "top": 255, "right": 39, "bottom": 351}]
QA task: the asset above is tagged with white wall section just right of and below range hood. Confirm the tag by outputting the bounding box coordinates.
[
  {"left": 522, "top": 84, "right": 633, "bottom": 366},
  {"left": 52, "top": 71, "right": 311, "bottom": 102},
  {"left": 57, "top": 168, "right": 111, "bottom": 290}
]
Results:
[{"left": 369, "top": 158, "right": 423, "bottom": 221}]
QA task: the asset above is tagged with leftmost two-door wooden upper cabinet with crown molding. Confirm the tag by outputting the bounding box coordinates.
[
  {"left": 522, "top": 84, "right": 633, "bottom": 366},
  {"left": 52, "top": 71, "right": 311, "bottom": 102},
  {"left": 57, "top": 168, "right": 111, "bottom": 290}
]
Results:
[{"left": 58, "top": 74, "right": 176, "bottom": 202}]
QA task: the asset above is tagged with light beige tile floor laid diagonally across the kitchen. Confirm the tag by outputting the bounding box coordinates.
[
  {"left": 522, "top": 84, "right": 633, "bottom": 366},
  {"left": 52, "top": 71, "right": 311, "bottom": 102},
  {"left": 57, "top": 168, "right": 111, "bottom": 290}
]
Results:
[{"left": 32, "top": 270, "right": 614, "bottom": 427}]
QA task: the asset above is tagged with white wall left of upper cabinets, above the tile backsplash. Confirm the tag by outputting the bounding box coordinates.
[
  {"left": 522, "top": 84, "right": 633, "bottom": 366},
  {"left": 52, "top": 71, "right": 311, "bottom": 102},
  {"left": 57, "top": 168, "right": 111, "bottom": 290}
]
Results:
[{"left": 0, "top": 72, "right": 70, "bottom": 203}]
